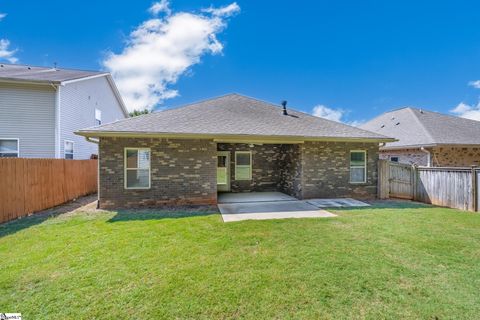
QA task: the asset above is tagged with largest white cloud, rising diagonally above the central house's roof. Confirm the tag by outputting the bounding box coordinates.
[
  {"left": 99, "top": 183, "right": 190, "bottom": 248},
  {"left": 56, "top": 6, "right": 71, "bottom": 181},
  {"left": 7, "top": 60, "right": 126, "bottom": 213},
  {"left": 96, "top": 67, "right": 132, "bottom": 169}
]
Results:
[{"left": 103, "top": 1, "right": 239, "bottom": 110}]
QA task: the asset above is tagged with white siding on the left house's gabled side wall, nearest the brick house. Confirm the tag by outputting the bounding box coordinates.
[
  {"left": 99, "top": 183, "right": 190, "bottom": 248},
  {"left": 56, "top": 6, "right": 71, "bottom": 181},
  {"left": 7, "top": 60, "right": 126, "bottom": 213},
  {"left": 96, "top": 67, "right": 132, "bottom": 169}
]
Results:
[{"left": 60, "top": 77, "right": 125, "bottom": 159}]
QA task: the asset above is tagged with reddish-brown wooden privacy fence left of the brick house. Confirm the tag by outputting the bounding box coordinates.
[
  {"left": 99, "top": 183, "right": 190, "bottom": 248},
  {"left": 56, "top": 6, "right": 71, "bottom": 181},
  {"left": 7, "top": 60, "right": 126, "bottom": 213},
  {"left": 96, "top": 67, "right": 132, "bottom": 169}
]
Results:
[{"left": 0, "top": 158, "right": 98, "bottom": 222}]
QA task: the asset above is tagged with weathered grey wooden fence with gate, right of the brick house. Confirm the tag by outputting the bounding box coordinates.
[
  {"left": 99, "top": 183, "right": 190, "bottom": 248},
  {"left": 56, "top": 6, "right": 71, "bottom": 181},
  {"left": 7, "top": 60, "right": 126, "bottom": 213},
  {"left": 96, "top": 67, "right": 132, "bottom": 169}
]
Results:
[{"left": 378, "top": 160, "right": 480, "bottom": 211}]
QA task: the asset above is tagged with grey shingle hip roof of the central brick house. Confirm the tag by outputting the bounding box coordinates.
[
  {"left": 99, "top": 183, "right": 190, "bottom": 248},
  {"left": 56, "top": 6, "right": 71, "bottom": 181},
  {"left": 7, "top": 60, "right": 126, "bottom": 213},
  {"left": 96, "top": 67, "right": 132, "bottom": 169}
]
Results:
[{"left": 78, "top": 94, "right": 391, "bottom": 141}]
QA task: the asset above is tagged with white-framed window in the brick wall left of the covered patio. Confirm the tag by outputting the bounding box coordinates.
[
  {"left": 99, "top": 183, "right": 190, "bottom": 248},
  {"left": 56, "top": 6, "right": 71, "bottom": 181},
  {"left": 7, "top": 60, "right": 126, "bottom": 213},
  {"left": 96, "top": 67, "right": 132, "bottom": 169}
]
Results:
[{"left": 125, "top": 148, "right": 150, "bottom": 189}]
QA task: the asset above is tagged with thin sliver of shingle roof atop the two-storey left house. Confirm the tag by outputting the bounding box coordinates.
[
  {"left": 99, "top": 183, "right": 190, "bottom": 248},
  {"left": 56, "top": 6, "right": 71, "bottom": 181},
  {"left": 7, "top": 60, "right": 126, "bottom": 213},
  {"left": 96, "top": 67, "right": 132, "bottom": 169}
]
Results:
[{"left": 0, "top": 63, "right": 106, "bottom": 83}]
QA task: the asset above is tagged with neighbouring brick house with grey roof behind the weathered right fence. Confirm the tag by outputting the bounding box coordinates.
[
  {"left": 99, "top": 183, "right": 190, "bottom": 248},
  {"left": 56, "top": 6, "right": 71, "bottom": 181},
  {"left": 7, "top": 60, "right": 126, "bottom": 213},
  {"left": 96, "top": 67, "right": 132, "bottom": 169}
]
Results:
[{"left": 361, "top": 108, "right": 480, "bottom": 167}]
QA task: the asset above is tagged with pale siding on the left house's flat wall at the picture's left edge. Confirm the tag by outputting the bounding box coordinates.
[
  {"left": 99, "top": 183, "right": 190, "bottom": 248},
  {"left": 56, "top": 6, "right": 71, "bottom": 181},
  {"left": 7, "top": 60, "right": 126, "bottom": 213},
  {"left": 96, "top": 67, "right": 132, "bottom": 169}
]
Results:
[{"left": 0, "top": 83, "right": 55, "bottom": 158}]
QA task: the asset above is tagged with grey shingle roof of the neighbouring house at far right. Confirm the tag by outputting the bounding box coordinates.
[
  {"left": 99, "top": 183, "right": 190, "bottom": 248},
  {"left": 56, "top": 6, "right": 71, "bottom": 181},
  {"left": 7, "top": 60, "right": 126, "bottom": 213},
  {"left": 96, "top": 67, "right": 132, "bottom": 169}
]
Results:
[{"left": 361, "top": 108, "right": 480, "bottom": 148}]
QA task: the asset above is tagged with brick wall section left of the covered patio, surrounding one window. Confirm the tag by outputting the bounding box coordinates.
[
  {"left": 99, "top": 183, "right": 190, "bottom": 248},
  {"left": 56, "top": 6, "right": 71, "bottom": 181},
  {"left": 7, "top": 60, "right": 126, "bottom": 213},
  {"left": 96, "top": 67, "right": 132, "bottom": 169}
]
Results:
[{"left": 99, "top": 138, "right": 217, "bottom": 209}]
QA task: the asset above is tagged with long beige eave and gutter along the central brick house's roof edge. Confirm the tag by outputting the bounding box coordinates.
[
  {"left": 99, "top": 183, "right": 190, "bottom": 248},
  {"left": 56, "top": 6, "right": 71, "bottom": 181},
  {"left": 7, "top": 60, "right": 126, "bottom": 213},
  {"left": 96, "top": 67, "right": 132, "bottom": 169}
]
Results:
[{"left": 75, "top": 130, "right": 396, "bottom": 143}]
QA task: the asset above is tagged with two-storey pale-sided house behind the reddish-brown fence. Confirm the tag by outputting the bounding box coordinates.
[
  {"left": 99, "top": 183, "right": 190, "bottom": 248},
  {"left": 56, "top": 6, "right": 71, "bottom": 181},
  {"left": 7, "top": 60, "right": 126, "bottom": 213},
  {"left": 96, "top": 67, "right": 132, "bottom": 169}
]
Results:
[{"left": 0, "top": 64, "right": 128, "bottom": 159}]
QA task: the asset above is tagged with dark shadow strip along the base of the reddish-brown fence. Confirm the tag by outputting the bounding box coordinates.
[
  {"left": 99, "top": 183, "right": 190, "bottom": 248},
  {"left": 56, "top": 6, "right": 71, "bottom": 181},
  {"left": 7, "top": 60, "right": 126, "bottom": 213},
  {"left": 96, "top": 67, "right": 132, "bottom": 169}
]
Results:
[{"left": 0, "top": 195, "right": 97, "bottom": 238}]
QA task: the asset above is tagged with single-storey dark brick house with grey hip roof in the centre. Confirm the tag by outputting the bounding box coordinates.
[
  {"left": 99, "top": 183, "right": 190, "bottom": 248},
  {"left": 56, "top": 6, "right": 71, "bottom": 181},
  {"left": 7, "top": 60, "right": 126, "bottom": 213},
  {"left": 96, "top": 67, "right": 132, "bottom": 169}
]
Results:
[{"left": 77, "top": 94, "right": 394, "bottom": 208}]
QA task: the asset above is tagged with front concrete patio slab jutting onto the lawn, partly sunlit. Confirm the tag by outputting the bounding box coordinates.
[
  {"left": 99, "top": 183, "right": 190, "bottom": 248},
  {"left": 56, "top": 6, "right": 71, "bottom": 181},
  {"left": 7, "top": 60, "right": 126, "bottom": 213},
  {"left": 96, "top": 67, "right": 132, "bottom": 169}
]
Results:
[{"left": 218, "top": 200, "right": 336, "bottom": 222}]
